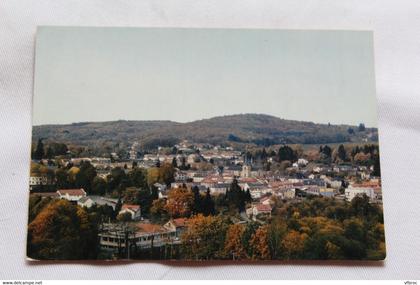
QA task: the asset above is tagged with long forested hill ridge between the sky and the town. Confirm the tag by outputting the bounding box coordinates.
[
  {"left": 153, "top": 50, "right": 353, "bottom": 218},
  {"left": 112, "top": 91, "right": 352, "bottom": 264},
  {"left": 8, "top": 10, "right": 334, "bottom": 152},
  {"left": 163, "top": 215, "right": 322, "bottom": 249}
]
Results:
[{"left": 33, "top": 114, "right": 378, "bottom": 147}]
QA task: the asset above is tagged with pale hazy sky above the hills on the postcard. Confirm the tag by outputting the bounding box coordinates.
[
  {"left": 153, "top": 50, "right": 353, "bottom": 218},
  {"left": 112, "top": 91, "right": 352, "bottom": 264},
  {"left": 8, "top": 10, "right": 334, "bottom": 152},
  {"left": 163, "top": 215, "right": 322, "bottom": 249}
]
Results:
[{"left": 33, "top": 27, "right": 377, "bottom": 126}]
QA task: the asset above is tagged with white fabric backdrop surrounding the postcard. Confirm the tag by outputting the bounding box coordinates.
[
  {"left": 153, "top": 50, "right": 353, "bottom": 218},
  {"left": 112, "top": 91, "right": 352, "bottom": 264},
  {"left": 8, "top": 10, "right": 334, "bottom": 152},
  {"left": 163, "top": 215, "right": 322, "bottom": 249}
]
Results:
[{"left": 0, "top": 0, "right": 420, "bottom": 279}]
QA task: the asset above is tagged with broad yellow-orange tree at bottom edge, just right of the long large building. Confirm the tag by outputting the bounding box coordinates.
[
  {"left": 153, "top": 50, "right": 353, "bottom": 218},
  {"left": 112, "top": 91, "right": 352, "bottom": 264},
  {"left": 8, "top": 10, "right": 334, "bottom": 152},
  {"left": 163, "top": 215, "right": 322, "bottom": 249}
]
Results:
[{"left": 181, "top": 214, "right": 229, "bottom": 260}]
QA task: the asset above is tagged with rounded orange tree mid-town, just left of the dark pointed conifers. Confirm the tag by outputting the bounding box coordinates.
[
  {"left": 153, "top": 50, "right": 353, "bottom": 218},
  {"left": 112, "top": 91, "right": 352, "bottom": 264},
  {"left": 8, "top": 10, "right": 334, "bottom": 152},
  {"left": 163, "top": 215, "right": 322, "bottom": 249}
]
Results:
[{"left": 166, "top": 188, "right": 194, "bottom": 218}]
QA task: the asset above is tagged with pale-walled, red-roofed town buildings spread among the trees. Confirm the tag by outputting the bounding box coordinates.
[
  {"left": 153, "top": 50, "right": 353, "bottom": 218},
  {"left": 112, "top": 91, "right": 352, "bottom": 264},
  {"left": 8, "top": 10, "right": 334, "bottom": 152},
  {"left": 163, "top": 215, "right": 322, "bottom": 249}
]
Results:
[{"left": 30, "top": 141, "right": 382, "bottom": 252}]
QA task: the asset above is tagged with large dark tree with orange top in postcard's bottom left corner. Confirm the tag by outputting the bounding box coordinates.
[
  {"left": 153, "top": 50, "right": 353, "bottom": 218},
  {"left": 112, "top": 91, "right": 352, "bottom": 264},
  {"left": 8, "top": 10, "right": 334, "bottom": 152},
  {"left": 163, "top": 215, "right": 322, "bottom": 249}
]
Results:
[{"left": 28, "top": 200, "right": 97, "bottom": 260}]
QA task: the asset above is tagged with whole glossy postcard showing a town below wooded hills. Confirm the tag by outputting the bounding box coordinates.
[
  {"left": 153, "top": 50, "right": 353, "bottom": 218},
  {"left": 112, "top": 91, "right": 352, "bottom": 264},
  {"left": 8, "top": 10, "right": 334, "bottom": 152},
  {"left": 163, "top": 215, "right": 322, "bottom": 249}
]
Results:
[{"left": 27, "top": 27, "right": 386, "bottom": 262}]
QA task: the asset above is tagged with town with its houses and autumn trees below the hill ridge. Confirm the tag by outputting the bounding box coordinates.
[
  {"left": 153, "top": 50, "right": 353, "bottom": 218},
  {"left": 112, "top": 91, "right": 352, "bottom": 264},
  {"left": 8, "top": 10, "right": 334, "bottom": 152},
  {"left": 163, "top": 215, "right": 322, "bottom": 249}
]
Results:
[{"left": 28, "top": 139, "right": 385, "bottom": 260}]
